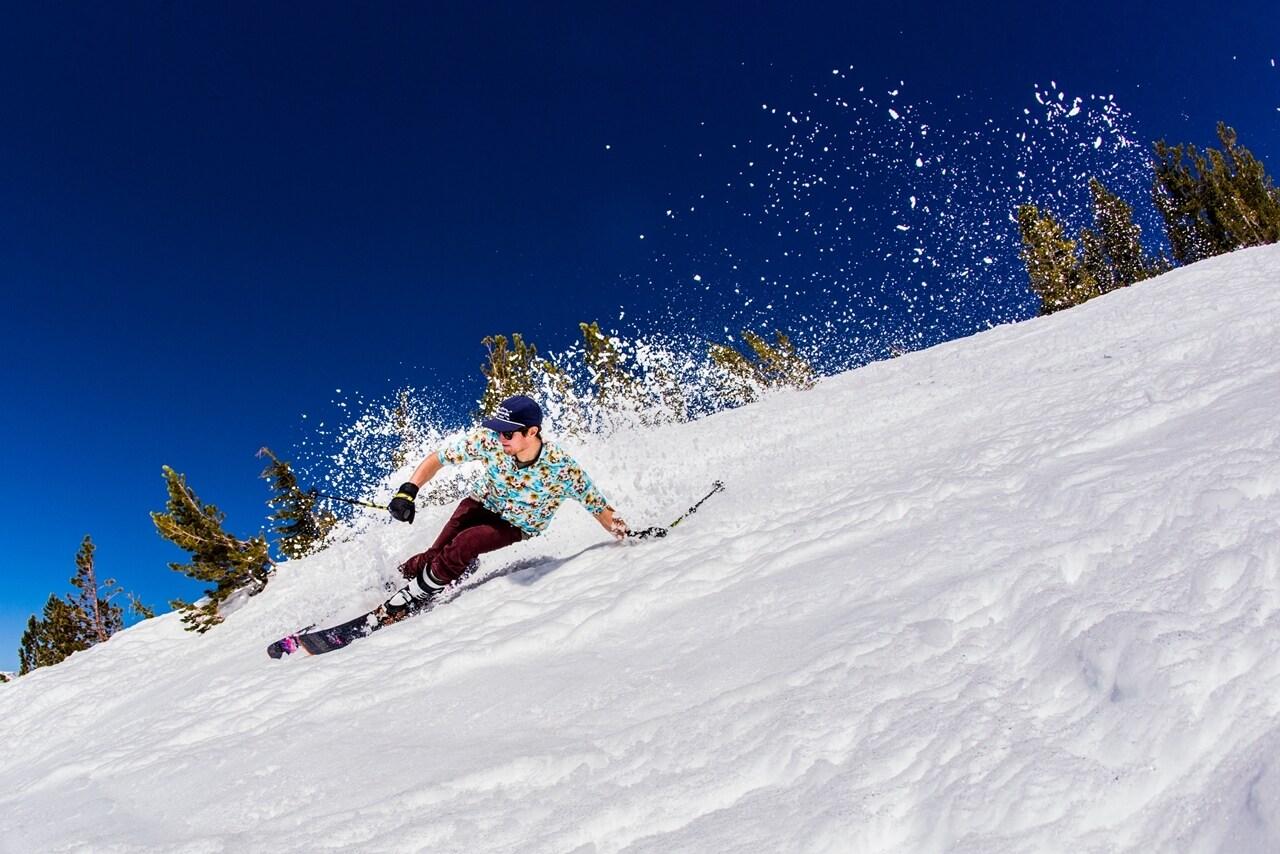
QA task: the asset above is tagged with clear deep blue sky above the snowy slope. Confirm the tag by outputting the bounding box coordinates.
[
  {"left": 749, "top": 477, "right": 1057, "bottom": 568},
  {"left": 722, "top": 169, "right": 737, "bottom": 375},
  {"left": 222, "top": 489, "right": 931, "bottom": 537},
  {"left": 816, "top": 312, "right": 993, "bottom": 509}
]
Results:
[{"left": 0, "top": 1, "right": 1280, "bottom": 668}]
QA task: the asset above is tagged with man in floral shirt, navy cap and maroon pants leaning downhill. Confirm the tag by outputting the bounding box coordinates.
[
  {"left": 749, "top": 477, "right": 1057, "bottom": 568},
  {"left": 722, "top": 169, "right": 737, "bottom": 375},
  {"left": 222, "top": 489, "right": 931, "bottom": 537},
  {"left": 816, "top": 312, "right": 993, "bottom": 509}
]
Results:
[{"left": 383, "top": 394, "right": 627, "bottom": 622}]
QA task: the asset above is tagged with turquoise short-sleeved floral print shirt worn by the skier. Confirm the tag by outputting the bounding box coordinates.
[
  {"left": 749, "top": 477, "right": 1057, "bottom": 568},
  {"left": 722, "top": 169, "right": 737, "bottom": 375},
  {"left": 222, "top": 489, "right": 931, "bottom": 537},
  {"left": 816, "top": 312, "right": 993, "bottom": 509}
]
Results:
[{"left": 436, "top": 428, "right": 609, "bottom": 536}]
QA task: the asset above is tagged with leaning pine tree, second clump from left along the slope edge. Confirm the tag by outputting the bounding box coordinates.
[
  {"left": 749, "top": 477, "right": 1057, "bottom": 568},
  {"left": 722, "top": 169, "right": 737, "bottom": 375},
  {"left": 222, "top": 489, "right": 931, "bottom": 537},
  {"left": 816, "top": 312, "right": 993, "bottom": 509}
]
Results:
[{"left": 151, "top": 466, "right": 274, "bottom": 634}]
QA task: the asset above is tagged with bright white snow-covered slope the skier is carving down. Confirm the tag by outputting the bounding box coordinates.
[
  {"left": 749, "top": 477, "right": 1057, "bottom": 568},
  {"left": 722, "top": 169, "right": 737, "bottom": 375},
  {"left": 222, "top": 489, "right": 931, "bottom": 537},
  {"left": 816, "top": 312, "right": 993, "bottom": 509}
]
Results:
[{"left": 0, "top": 247, "right": 1280, "bottom": 854}]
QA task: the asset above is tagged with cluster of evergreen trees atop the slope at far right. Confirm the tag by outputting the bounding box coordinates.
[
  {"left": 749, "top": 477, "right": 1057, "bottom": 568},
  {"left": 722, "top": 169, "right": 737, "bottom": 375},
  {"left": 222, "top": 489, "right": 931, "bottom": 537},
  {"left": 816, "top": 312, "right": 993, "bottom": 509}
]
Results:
[{"left": 1018, "top": 123, "right": 1280, "bottom": 315}]
